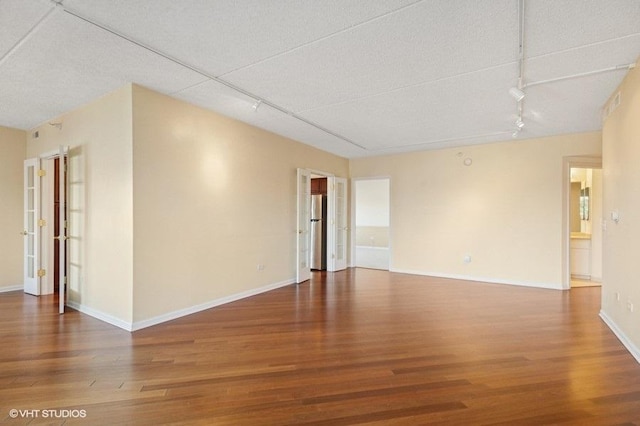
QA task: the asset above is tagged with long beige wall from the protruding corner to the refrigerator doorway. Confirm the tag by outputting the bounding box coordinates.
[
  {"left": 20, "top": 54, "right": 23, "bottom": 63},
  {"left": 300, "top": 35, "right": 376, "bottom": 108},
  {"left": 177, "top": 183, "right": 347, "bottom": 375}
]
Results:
[{"left": 133, "top": 86, "right": 349, "bottom": 321}]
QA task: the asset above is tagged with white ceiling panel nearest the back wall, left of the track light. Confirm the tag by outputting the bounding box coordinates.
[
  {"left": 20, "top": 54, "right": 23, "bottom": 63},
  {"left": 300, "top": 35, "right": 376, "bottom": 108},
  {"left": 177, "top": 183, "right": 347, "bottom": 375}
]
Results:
[{"left": 301, "top": 64, "right": 518, "bottom": 149}]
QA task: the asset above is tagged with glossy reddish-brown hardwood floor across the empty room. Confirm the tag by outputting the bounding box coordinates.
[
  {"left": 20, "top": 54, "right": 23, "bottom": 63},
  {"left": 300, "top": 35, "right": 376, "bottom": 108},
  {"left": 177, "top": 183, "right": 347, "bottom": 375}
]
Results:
[{"left": 0, "top": 269, "right": 640, "bottom": 425}]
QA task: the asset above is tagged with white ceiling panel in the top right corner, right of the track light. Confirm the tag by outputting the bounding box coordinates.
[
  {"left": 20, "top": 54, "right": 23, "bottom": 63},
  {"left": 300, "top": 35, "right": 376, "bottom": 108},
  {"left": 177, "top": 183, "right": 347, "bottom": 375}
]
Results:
[{"left": 525, "top": 0, "right": 640, "bottom": 58}]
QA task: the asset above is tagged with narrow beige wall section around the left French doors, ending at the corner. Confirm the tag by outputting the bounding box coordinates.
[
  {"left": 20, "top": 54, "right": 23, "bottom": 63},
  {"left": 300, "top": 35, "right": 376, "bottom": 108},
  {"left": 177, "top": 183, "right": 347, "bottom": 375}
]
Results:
[{"left": 27, "top": 85, "right": 133, "bottom": 326}]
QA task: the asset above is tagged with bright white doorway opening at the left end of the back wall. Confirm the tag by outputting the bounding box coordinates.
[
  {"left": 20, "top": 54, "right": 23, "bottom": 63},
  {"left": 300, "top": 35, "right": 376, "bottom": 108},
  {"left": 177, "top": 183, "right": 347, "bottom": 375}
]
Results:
[{"left": 353, "top": 178, "right": 390, "bottom": 270}]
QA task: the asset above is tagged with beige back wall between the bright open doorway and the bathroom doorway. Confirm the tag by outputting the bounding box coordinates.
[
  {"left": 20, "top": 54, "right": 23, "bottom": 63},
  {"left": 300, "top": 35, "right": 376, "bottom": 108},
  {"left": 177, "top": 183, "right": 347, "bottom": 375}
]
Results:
[{"left": 351, "top": 132, "right": 601, "bottom": 288}]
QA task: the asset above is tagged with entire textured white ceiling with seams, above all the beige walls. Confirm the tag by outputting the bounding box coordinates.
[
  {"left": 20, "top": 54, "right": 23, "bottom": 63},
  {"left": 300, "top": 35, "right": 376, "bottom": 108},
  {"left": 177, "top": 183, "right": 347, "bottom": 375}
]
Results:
[{"left": 0, "top": 0, "right": 640, "bottom": 158}]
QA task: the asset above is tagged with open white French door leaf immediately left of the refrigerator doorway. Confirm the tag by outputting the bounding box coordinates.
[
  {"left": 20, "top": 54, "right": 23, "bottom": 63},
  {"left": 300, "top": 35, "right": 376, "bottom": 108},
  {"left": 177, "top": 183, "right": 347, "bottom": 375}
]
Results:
[{"left": 296, "top": 169, "right": 311, "bottom": 283}]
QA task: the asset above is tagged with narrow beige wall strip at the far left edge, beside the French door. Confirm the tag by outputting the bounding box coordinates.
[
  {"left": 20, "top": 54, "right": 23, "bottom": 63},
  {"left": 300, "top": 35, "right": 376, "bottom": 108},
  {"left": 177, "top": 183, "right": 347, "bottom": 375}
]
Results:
[{"left": 0, "top": 126, "right": 27, "bottom": 291}]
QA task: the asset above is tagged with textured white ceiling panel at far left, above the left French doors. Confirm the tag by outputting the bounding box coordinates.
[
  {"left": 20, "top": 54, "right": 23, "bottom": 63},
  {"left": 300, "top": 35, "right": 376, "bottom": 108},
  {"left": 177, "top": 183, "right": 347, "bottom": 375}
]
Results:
[{"left": 0, "top": 11, "right": 204, "bottom": 129}]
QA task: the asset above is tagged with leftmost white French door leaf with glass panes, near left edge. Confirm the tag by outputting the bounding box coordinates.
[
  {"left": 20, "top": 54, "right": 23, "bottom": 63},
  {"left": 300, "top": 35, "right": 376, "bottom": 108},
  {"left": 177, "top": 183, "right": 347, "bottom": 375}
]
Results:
[{"left": 22, "top": 158, "right": 41, "bottom": 296}]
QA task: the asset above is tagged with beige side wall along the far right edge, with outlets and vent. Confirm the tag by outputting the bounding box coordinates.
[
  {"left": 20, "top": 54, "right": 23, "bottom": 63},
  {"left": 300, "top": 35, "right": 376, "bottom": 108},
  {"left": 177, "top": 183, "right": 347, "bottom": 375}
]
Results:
[{"left": 602, "top": 56, "right": 640, "bottom": 361}]
